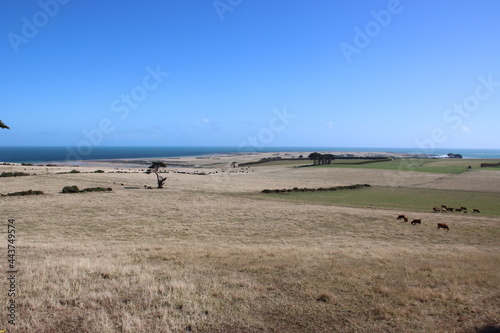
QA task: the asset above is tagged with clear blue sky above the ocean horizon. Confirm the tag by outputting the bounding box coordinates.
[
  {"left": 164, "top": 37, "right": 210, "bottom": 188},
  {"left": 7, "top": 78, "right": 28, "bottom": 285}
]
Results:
[{"left": 0, "top": 0, "right": 500, "bottom": 148}]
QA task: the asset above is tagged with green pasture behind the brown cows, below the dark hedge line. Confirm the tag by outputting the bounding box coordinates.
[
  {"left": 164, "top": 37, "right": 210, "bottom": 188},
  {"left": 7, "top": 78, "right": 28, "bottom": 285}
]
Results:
[{"left": 260, "top": 186, "right": 500, "bottom": 215}]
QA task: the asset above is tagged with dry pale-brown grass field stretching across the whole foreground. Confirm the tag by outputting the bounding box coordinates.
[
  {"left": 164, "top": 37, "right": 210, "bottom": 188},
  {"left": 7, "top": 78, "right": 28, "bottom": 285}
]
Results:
[{"left": 0, "top": 157, "right": 500, "bottom": 333}]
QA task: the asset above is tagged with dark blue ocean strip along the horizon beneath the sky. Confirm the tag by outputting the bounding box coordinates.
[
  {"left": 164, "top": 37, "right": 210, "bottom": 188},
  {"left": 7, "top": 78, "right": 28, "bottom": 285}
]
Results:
[{"left": 0, "top": 146, "right": 500, "bottom": 163}]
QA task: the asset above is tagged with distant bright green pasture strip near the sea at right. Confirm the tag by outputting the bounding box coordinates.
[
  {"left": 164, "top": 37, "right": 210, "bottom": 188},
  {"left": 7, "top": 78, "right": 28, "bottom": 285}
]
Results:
[{"left": 315, "top": 158, "right": 500, "bottom": 173}]
